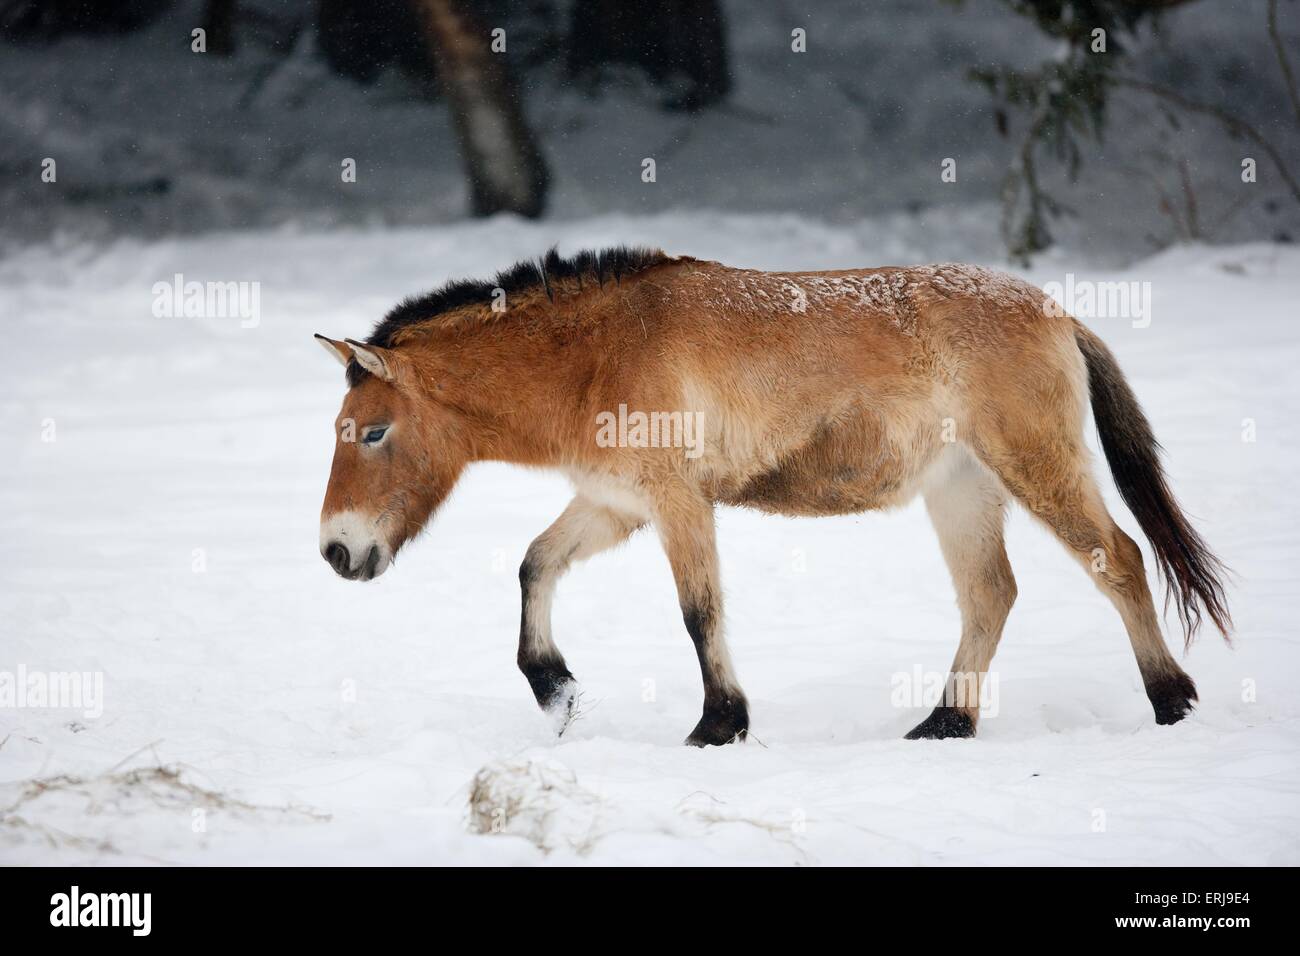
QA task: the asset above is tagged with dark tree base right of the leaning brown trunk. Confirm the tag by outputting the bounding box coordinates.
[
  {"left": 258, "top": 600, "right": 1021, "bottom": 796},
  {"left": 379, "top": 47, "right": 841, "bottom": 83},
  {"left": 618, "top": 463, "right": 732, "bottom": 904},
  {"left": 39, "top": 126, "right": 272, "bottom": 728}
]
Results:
[{"left": 568, "top": 0, "right": 731, "bottom": 111}]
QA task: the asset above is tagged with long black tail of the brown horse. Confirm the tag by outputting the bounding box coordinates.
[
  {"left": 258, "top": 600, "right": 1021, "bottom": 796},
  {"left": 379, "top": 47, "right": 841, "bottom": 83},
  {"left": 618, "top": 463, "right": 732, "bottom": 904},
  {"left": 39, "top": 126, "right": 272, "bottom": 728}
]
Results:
[{"left": 1074, "top": 323, "right": 1232, "bottom": 645}]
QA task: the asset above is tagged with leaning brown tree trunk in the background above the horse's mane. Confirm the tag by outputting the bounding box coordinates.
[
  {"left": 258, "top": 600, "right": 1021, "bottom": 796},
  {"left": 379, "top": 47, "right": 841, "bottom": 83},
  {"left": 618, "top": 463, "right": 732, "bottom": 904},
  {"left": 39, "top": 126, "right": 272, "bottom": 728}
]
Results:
[{"left": 413, "top": 0, "right": 550, "bottom": 217}]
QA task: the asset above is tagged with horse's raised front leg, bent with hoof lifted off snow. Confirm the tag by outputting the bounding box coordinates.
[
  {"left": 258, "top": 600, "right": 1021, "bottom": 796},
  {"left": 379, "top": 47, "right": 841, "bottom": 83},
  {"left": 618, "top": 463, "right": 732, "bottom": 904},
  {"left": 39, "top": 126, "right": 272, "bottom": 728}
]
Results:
[{"left": 516, "top": 496, "right": 642, "bottom": 734}]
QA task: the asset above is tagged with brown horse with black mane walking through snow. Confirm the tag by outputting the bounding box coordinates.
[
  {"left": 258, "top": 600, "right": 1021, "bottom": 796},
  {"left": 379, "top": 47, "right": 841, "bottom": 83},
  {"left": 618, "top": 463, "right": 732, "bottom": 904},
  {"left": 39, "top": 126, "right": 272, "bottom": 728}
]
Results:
[{"left": 317, "top": 248, "right": 1230, "bottom": 745}]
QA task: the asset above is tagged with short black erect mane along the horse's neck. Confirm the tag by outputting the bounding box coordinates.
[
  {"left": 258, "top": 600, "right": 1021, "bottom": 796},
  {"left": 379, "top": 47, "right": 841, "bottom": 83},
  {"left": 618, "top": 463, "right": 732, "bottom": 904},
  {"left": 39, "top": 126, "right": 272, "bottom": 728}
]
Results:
[{"left": 347, "top": 246, "right": 668, "bottom": 385}]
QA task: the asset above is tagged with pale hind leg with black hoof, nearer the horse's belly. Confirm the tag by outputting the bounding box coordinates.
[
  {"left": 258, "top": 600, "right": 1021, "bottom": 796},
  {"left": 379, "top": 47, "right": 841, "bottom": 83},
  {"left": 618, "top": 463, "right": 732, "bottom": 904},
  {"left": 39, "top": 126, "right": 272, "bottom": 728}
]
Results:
[{"left": 906, "top": 446, "right": 1015, "bottom": 740}]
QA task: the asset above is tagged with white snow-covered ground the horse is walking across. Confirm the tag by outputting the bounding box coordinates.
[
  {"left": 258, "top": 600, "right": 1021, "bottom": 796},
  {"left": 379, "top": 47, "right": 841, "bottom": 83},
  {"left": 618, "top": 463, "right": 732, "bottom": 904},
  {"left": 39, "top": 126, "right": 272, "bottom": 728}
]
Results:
[{"left": 0, "top": 217, "right": 1300, "bottom": 865}]
